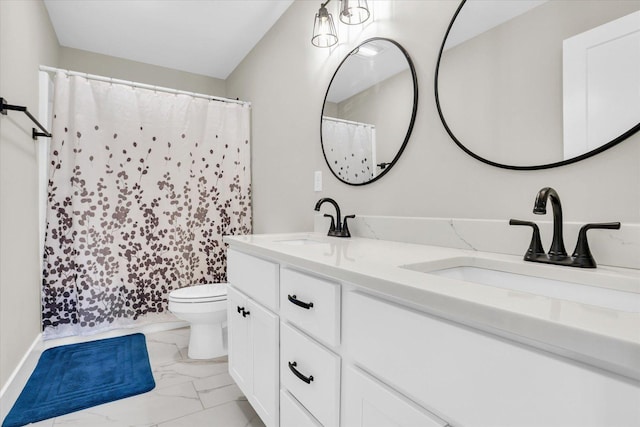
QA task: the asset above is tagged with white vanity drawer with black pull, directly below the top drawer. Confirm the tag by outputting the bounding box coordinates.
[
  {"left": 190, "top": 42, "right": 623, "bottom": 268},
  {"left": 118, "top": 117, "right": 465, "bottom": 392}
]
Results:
[{"left": 280, "top": 323, "right": 340, "bottom": 427}]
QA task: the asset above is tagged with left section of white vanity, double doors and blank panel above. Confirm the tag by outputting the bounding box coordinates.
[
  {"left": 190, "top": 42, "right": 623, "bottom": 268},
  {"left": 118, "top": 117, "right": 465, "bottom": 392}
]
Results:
[{"left": 227, "top": 251, "right": 280, "bottom": 427}]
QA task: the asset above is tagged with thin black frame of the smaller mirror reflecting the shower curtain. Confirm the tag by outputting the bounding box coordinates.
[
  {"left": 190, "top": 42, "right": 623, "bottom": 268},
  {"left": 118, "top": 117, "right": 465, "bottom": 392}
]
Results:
[{"left": 320, "top": 37, "right": 418, "bottom": 186}]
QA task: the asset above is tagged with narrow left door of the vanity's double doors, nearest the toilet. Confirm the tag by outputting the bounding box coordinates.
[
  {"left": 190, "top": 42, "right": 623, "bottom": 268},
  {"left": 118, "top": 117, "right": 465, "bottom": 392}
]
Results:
[{"left": 227, "top": 286, "right": 252, "bottom": 395}]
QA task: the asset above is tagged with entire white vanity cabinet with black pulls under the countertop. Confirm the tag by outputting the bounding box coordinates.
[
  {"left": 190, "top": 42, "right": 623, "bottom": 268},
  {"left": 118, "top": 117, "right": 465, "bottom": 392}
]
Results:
[{"left": 228, "top": 244, "right": 640, "bottom": 427}]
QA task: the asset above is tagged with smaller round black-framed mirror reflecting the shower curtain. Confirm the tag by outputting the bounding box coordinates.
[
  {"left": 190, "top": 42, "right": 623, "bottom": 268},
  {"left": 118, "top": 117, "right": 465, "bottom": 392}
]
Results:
[{"left": 320, "top": 38, "right": 418, "bottom": 185}]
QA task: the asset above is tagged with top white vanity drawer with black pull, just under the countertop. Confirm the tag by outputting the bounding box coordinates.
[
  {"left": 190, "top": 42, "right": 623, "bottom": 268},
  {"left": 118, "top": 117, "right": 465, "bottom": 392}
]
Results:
[{"left": 280, "top": 268, "right": 340, "bottom": 347}]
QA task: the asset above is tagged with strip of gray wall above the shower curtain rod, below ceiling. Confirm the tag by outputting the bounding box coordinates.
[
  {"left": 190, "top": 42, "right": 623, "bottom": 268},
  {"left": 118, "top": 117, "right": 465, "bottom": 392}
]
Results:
[{"left": 60, "top": 47, "right": 227, "bottom": 97}]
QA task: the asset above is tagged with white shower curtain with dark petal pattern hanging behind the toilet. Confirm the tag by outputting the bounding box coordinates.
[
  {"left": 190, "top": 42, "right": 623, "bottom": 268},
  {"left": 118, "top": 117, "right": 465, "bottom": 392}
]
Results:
[{"left": 42, "top": 72, "right": 251, "bottom": 338}]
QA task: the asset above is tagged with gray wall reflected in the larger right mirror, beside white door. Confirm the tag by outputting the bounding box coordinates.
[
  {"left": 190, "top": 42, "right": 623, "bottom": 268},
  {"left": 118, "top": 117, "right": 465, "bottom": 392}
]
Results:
[{"left": 439, "top": 0, "right": 640, "bottom": 165}]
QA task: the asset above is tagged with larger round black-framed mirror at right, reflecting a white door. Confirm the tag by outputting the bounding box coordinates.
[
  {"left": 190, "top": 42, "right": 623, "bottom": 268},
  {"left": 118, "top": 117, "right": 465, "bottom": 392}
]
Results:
[{"left": 435, "top": 0, "right": 640, "bottom": 170}]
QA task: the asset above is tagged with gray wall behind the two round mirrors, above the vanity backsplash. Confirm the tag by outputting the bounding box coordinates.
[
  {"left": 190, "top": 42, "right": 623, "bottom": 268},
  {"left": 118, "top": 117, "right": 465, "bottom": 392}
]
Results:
[{"left": 227, "top": 0, "right": 640, "bottom": 233}]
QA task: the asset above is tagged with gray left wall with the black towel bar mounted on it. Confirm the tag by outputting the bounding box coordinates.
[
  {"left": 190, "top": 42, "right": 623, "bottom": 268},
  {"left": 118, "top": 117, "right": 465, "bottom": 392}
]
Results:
[{"left": 0, "top": 0, "right": 58, "bottom": 388}]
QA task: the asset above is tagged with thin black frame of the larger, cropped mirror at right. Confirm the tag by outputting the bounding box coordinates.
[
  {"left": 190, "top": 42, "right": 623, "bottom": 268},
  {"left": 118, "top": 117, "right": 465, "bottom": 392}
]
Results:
[{"left": 434, "top": 0, "right": 640, "bottom": 170}]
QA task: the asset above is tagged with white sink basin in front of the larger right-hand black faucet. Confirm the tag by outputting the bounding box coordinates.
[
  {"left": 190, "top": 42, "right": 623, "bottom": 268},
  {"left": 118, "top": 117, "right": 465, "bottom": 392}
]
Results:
[{"left": 401, "top": 260, "right": 640, "bottom": 313}]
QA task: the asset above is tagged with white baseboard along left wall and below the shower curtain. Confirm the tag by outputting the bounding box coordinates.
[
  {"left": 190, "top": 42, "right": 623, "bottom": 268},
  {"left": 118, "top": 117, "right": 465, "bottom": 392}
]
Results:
[{"left": 0, "top": 320, "right": 189, "bottom": 420}]
